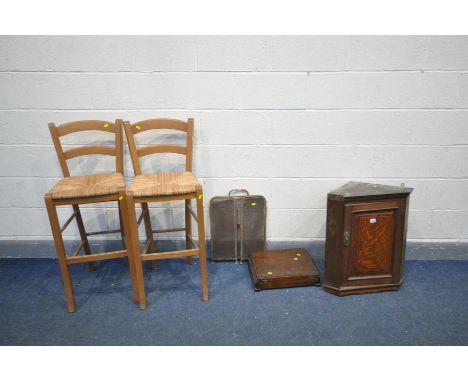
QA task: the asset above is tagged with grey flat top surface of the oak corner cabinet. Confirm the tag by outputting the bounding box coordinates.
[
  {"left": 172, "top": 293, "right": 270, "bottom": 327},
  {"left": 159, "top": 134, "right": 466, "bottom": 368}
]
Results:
[{"left": 328, "top": 182, "right": 413, "bottom": 199}]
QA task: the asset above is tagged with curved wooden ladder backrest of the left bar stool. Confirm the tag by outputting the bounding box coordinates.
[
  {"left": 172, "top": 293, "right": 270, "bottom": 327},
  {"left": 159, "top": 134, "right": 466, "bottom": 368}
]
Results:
[{"left": 49, "top": 119, "right": 124, "bottom": 177}]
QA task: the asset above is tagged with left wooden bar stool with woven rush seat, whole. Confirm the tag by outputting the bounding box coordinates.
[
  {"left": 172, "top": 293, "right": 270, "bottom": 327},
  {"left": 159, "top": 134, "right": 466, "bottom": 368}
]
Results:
[{"left": 44, "top": 120, "right": 139, "bottom": 312}]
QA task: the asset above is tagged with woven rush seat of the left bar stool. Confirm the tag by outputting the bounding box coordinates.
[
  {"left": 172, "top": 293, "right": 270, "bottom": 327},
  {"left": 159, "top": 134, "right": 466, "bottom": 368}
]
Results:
[{"left": 50, "top": 172, "right": 125, "bottom": 199}]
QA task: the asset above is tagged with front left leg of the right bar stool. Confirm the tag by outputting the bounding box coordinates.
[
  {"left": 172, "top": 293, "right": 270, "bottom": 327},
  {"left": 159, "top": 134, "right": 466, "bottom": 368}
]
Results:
[{"left": 124, "top": 193, "right": 146, "bottom": 309}]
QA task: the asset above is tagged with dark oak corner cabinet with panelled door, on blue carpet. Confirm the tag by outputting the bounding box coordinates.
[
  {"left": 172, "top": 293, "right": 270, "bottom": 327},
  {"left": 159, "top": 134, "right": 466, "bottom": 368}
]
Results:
[{"left": 323, "top": 182, "right": 413, "bottom": 296}]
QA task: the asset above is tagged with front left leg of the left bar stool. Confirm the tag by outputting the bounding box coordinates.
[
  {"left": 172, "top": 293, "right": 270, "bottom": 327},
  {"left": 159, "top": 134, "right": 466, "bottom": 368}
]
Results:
[{"left": 44, "top": 195, "right": 75, "bottom": 313}]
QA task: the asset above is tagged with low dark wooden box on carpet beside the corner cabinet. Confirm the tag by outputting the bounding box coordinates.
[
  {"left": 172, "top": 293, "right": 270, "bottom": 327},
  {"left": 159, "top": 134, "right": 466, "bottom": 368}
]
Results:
[{"left": 249, "top": 248, "right": 320, "bottom": 291}]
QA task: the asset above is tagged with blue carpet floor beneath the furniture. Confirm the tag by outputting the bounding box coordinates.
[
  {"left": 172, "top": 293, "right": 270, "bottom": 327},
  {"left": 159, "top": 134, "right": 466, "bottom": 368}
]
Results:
[{"left": 0, "top": 259, "right": 468, "bottom": 345}]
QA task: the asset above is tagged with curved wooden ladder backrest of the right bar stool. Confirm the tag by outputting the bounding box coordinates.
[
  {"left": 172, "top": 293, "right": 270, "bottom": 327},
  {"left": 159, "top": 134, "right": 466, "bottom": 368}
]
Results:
[{"left": 124, "top": 118, "right": 194, "bottom": 175}]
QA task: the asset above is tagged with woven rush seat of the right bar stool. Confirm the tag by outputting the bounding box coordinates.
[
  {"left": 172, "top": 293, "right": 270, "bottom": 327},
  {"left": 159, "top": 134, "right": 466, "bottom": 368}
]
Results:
[{"left": 128, "top": 172, "right": 202, "bottom": 197}]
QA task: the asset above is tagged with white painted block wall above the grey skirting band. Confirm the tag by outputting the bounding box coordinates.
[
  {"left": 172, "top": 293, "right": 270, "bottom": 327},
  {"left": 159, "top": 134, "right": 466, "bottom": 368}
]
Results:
[{"left": 0, "top": 36, "right": 468, "bottom": 242}]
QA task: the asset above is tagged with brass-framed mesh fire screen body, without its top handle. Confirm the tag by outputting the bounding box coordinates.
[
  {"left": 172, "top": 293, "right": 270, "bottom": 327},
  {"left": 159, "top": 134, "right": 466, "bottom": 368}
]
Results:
[{"left": 210, "top": 191, "right": 266, "bottom": 262}]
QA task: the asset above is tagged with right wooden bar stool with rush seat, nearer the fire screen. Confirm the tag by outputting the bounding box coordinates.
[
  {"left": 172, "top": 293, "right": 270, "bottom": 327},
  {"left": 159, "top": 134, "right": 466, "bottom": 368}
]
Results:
[{"left": 124, "top": 119, "right": 208, "bottom": 309}]
